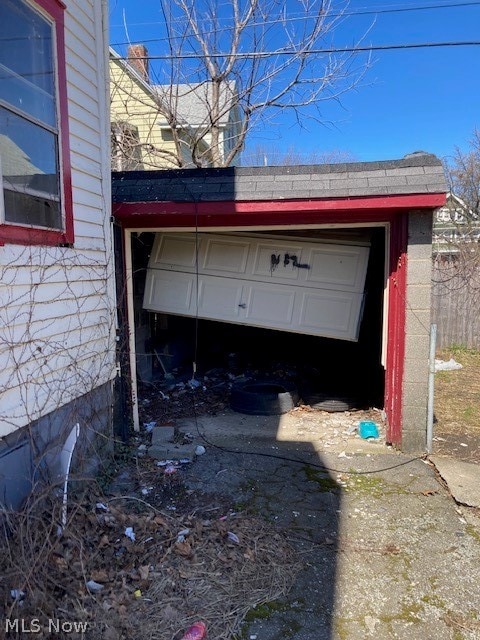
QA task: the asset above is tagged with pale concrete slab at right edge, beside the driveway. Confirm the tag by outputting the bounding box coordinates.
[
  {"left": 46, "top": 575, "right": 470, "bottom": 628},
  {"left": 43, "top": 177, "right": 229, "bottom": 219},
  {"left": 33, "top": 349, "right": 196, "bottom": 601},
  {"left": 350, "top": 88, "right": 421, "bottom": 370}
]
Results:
[{"left": 430, "top": 456, "right": 480, "bottom": 507}]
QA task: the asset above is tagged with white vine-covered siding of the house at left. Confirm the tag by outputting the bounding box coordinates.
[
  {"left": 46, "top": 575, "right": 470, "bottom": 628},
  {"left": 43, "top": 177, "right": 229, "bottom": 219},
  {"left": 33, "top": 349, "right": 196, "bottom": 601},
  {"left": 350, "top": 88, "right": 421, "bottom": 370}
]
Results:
[{"left": 0, "top": 0, "right": 115, "bottom": 437}]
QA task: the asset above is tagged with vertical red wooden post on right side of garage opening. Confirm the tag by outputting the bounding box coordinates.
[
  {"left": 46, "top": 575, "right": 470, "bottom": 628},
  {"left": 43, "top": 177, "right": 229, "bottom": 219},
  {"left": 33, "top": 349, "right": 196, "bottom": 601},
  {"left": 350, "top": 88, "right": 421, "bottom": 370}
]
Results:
[{"left": 385, "top": 212, "right": 408, "bottom": 446}]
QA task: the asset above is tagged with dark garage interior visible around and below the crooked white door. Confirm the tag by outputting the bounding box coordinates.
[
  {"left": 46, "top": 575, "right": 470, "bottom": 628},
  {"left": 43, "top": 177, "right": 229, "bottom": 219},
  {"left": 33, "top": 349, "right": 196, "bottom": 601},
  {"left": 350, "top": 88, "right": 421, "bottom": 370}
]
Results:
[{"left": 132, "top": 228, "right": 385, "bottom": 409}]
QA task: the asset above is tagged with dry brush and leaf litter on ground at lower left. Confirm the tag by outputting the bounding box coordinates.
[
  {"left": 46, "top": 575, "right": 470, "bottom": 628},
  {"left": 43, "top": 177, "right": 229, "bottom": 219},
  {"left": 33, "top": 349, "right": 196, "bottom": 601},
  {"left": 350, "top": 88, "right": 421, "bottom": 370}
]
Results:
[{"left": 0, "top": 480, "right": 301, "bottom": 640}]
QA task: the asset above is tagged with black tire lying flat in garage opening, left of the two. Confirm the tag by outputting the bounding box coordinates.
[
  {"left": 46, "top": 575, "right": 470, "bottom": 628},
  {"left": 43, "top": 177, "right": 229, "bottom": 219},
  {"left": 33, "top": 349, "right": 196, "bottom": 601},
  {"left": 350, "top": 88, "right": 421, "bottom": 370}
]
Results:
[{"left": 230, "top": 379, "right": 299, "bottom": 416}]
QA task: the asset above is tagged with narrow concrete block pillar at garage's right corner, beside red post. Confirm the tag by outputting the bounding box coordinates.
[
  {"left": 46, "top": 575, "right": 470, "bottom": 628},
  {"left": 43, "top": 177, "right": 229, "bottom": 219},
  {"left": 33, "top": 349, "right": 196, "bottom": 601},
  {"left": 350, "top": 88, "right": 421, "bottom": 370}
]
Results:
[{"left": 402, "top": 211, "right": 433, "bottom": 453}]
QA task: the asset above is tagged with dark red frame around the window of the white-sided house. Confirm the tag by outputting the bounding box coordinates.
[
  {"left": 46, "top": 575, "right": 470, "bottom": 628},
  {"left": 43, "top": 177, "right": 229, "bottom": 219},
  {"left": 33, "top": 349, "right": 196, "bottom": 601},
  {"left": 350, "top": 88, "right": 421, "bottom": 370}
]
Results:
[{"left": 0, "top": 0, "right": 74, "bottom": 246}]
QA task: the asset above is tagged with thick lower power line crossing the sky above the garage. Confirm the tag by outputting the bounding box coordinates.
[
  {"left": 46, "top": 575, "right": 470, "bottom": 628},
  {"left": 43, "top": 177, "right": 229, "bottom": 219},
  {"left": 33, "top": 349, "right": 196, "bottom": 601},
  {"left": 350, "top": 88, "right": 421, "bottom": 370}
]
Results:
[{"left": 114, "top": 40, "right": 480, "bottom": 60}]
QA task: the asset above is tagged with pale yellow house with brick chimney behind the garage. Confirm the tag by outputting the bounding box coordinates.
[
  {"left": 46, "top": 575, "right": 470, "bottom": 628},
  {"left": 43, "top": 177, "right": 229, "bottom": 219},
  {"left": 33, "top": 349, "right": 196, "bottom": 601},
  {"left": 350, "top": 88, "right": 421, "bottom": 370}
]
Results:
[{"left": 110, "top": 45, "right": 240, "bottom": 170}]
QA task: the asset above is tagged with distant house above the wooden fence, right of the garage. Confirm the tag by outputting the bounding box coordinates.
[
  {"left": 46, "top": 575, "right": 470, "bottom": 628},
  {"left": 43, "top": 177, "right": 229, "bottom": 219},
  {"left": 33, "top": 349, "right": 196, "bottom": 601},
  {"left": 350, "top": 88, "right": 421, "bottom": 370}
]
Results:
[{"left": 433, "top": 192, "right": 480, "bottom": 260}]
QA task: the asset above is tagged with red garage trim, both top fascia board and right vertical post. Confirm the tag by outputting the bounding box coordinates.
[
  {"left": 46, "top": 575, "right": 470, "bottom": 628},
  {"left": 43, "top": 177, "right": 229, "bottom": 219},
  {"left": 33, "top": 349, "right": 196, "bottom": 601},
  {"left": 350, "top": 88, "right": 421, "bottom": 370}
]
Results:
[{"left": 113, "top": 193, "right": 445, "bottom": 445}]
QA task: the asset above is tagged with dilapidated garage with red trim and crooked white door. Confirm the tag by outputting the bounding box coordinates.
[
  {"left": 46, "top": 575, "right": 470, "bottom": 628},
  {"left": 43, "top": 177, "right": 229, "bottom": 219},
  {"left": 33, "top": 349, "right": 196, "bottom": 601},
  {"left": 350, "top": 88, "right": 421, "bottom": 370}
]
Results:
[{"left": 113, "top": 154, "right": 446, "bottom": 451}]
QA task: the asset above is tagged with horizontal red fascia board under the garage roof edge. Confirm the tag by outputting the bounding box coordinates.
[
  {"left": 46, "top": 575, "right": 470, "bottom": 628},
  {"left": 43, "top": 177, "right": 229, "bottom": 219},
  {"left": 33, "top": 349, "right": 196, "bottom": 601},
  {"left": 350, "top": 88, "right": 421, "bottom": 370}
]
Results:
[{"left": 113, "top": 193, "right": 445, "bottom": 228}]
